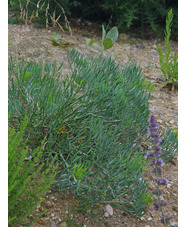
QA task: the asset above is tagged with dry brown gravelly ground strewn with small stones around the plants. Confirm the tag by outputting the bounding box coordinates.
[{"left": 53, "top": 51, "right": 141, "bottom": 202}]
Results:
[{"left": 8, "top": 20, "right": 178, "bottom": 227}]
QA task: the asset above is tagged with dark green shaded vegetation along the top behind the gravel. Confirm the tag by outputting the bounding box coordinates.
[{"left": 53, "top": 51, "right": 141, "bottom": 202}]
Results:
[{"left": 9, "top": 0, "right": 178, "bottom": 38}]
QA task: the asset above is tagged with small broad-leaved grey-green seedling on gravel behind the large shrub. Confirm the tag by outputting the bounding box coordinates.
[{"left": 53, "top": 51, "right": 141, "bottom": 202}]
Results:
[{"left": 86, "top": 25, "right": 119, "bottom": 50}]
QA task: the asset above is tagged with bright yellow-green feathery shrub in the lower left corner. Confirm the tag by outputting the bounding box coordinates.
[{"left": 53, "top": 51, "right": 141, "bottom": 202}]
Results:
[{"left": 8, "top": 118, "right": 57, "bottom": 227}]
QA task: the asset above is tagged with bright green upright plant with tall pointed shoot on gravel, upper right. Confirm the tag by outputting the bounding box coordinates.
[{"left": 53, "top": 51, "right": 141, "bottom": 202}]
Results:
[{"left": 158, "top": 9, "right": 178, "bottom": 87}]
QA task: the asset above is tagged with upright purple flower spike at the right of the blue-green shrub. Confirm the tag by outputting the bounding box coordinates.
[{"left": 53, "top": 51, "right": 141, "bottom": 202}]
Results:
[{"left": 146, "top": 115, "right": 172, "bottom": 227}]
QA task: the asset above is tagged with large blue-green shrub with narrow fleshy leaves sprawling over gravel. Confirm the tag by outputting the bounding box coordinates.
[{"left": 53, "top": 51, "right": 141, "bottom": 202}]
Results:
[{"left": 9, "top": 50, "right": 177, "bottom": 216}]
